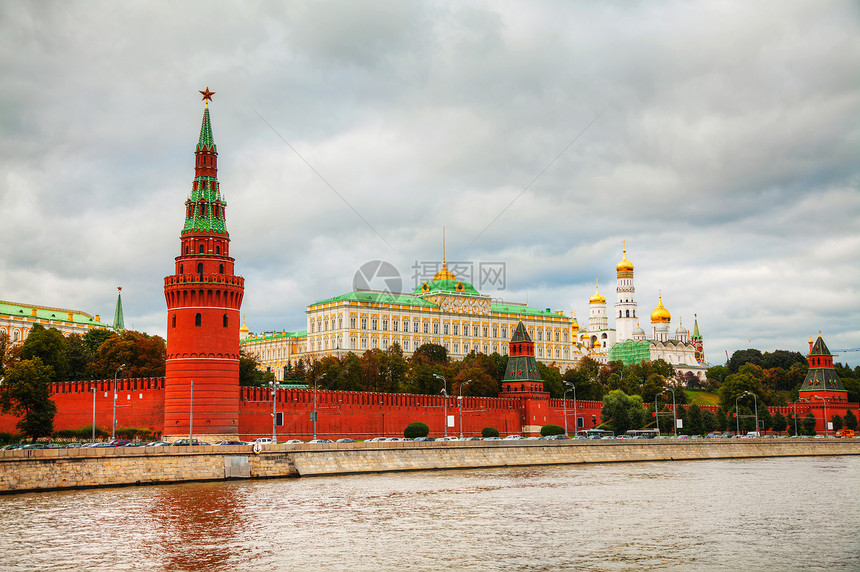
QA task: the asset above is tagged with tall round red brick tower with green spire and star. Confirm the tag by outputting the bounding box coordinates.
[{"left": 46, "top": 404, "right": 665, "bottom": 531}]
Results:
[{"left": 164, "top": 87, "right": 245, "bottom": 438}]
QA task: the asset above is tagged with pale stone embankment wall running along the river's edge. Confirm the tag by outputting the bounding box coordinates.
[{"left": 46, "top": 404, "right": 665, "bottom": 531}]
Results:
[{"left": 0, "top": 439, "right": 860, "bottom": 493}]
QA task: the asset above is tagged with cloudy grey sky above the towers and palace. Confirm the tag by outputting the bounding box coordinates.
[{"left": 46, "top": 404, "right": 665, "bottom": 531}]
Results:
[{"left": 0, "top": 0, "right": 860, "bottom": 364}]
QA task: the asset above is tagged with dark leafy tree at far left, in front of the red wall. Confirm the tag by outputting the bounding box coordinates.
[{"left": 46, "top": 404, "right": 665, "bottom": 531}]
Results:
[{"left": 0, "top": 357, "right": 57, "bottom": 442}]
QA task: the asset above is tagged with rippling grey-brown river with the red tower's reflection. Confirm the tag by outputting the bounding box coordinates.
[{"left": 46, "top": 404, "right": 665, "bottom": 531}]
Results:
[{"left": 0, "top": 456, "right": 860, "bottom": 571}]
